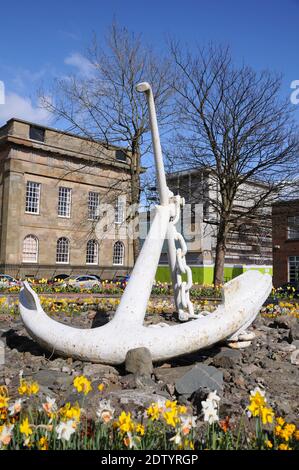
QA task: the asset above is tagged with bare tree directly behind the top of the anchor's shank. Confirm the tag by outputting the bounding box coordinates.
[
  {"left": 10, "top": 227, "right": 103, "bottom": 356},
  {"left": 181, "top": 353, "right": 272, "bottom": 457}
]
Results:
[{"left": 42, "top": 23, "right": 175, "bottom": 259}]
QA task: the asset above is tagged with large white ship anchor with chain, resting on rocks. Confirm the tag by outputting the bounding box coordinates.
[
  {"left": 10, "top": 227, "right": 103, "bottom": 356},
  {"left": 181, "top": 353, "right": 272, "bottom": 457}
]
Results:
[{"left": 19, "top": 82, "right": 272, "bottom": 364}]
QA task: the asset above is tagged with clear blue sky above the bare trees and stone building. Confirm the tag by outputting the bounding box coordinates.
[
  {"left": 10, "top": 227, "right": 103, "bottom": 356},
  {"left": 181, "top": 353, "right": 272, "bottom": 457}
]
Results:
[{"left": 0, "top": 0, "right": 299, "bottom": 124}]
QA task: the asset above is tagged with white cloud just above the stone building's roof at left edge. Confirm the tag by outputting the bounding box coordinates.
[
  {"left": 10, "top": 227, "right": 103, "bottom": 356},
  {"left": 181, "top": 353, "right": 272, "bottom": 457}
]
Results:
[{"left": 0, "top": 93, "right": 50, "bottom": 125}]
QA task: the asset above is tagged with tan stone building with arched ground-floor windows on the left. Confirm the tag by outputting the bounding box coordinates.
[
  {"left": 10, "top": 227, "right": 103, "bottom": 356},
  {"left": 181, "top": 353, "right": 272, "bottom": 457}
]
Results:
[{"left": 0, "top": 119, "right": 133, "bottom": 279}]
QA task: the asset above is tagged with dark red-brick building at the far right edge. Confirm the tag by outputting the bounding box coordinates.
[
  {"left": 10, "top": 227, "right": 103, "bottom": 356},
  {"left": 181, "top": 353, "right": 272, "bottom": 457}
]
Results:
[{"left": 272, "top": 199, "right": 299, "bottom": 287}]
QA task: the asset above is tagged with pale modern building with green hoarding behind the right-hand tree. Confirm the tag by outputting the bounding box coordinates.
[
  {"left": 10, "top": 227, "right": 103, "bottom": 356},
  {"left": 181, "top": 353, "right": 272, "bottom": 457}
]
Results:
[{"left": 157, "top": 169, "right": 272, "bottom": 284}]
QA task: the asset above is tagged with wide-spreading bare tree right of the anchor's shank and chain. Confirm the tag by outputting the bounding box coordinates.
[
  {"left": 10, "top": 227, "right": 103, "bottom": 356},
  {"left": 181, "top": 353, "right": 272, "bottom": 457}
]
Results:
[{"left": 171, "top": 43, "right": 299, "bottom": 284}]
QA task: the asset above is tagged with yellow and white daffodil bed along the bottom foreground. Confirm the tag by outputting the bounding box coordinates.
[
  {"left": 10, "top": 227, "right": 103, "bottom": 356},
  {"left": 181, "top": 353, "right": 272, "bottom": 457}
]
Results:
[{"left": 0, "top": 373, "right": 299, "bottom": 450}]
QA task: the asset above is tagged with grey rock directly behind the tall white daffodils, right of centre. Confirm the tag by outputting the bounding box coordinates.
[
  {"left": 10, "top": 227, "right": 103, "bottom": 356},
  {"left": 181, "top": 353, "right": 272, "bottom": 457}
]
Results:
[{"left": 175, "top": 364, "right": 223, "bottom": 396}]
